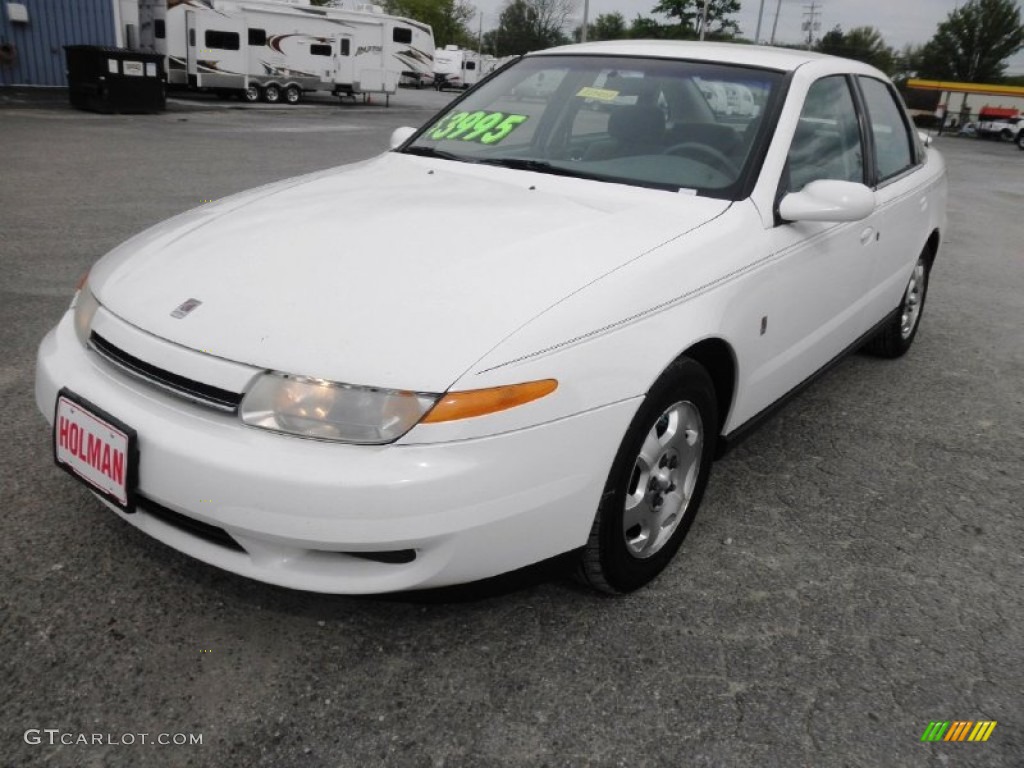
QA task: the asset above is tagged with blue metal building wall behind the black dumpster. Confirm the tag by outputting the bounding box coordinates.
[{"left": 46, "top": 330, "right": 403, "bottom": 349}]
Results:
[{"left": 0, "top": 0, "right": 118, "bottom": 85}]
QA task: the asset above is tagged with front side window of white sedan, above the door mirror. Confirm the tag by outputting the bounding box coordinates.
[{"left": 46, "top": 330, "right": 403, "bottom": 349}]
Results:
[{"left": 786, "top": 75, "right": 864, "bottom": 191}]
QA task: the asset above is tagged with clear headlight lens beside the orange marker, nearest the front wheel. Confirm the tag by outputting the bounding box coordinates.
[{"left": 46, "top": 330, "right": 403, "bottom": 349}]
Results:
[{"left": 240, "top": 373, "right": 439, "bottom": 443}]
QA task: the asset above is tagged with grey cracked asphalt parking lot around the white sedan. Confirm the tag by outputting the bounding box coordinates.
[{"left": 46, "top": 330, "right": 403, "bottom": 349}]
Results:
[{"left": 0, "top": 91, "right": 1024, "bottom": 768}]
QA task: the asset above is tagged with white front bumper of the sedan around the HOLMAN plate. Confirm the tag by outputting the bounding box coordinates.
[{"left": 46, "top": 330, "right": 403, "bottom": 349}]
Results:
[{"left": 36, "top": 312, "right": 638, "bottom": 594}]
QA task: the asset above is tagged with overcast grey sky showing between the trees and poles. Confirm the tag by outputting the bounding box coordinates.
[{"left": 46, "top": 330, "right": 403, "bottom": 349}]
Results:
[{"left": 470, "top": 0, "right": 1024, "bottom": 74}]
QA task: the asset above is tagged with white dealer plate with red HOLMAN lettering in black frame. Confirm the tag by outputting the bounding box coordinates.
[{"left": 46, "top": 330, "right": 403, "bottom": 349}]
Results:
[{"left": 53, "top": 389, "right": 138, "bottom": 512}]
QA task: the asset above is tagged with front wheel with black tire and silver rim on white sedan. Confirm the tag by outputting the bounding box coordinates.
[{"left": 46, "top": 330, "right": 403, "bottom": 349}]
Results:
[{"left": 578, "top": 357, "right": 718, "bottom": 594}]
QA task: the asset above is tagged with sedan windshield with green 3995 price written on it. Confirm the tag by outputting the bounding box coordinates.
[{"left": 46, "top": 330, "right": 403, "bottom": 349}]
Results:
[{"left": 403, "top": 54, "right": 782, "bottom": 199}]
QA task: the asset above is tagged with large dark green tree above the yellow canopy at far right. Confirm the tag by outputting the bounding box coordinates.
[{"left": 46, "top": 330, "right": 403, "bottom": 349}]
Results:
[{"left": 919, "top": 0, "right": 1024, "bottom": 83}]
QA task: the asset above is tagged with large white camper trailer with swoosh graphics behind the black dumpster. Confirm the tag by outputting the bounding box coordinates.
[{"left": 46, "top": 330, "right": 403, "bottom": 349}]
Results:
[{"left": 138, "top": 0, "right": 433, "bottom": 103}]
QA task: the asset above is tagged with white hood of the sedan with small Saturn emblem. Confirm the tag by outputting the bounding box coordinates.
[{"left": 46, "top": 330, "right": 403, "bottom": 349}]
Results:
[{"left": 90, "top": 154, "right": 729, "bottom": 391}]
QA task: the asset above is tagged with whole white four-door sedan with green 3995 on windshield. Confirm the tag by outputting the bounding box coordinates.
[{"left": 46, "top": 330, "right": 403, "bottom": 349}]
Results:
[{"left": 36, "top": 41, "right": 946, "bottom": 593}]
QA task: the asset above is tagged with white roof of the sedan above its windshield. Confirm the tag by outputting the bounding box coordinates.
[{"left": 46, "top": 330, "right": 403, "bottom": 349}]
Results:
[{"left": 527, "top": 40, "right": 837, "bottom": 72}]
